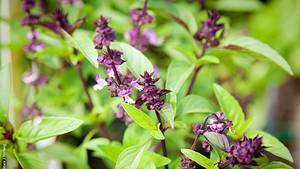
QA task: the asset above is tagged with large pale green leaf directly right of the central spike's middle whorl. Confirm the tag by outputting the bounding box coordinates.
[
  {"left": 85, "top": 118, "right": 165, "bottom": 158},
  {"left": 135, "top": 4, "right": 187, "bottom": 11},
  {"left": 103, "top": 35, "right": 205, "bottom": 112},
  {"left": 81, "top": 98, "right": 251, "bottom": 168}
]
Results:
[{"left": 112, "top": 42, "right": 153, "bottom": 77}]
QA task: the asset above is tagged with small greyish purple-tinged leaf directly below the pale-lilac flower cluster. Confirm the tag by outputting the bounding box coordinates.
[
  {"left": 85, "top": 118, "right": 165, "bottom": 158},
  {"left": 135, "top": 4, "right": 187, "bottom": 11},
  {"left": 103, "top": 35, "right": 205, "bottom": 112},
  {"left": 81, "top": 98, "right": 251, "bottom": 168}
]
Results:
[{"left": 204, "top": 132, "right": 229, "bottom": 150}]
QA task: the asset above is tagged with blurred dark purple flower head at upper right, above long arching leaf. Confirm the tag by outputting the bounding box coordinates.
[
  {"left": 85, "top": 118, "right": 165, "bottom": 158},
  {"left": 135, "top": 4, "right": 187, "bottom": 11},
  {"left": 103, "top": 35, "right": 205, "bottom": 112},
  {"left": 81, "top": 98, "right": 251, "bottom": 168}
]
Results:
[{"left": 194, "top": 10, "right": 224, "bottom": 49}]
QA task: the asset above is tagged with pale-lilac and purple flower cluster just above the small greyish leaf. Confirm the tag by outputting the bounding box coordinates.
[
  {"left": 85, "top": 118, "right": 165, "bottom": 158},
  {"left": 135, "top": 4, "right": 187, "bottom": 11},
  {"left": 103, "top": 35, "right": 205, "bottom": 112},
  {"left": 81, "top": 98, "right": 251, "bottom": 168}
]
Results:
[{"left": 192, "top": 112, "right": 232, "bottom": 152}]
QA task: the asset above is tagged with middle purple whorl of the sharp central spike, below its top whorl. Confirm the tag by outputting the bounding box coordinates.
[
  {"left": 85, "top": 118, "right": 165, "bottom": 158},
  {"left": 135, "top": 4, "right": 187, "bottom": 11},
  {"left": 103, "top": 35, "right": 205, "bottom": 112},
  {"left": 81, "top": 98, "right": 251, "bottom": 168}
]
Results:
[{"left": 97, "top": 49, "right": 124, "bottom": 66}]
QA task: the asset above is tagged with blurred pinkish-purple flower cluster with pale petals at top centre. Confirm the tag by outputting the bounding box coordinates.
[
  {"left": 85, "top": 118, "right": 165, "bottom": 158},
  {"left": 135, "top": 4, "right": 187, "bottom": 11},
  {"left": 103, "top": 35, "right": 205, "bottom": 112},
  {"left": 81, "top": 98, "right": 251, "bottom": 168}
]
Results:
[{"left": 124, "top": 2, "right": 161, "bottom": 51}]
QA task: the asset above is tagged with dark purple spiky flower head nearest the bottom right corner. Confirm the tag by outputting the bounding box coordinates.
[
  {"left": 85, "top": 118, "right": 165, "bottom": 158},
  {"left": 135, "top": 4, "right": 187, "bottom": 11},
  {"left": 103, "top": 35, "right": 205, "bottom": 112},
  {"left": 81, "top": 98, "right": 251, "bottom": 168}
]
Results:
[{"left": 227, "top": 136, "right": 263, "bottom": 165}]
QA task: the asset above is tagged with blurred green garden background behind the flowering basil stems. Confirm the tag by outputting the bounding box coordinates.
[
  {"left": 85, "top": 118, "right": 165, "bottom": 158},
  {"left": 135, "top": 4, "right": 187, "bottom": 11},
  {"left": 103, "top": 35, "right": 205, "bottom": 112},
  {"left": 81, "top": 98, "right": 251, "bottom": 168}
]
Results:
[{"left": 0, "top": 0, "right": 300, "bottom": 168}]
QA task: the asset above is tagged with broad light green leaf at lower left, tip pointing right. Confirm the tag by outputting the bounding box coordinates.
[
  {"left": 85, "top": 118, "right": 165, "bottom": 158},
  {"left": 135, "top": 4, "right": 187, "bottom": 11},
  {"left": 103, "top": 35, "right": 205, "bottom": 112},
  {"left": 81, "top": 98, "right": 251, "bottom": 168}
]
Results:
[{"left": 16, "top": 117, "right": 83, "bottom": 143}]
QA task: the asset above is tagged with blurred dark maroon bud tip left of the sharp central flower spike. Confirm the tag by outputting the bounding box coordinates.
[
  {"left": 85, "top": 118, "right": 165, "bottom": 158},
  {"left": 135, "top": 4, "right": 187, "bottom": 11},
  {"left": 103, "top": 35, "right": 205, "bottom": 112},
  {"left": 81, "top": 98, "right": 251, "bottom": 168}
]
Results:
[{"left": 53, "top": 9, "right": 72, "bottom": 32}]
